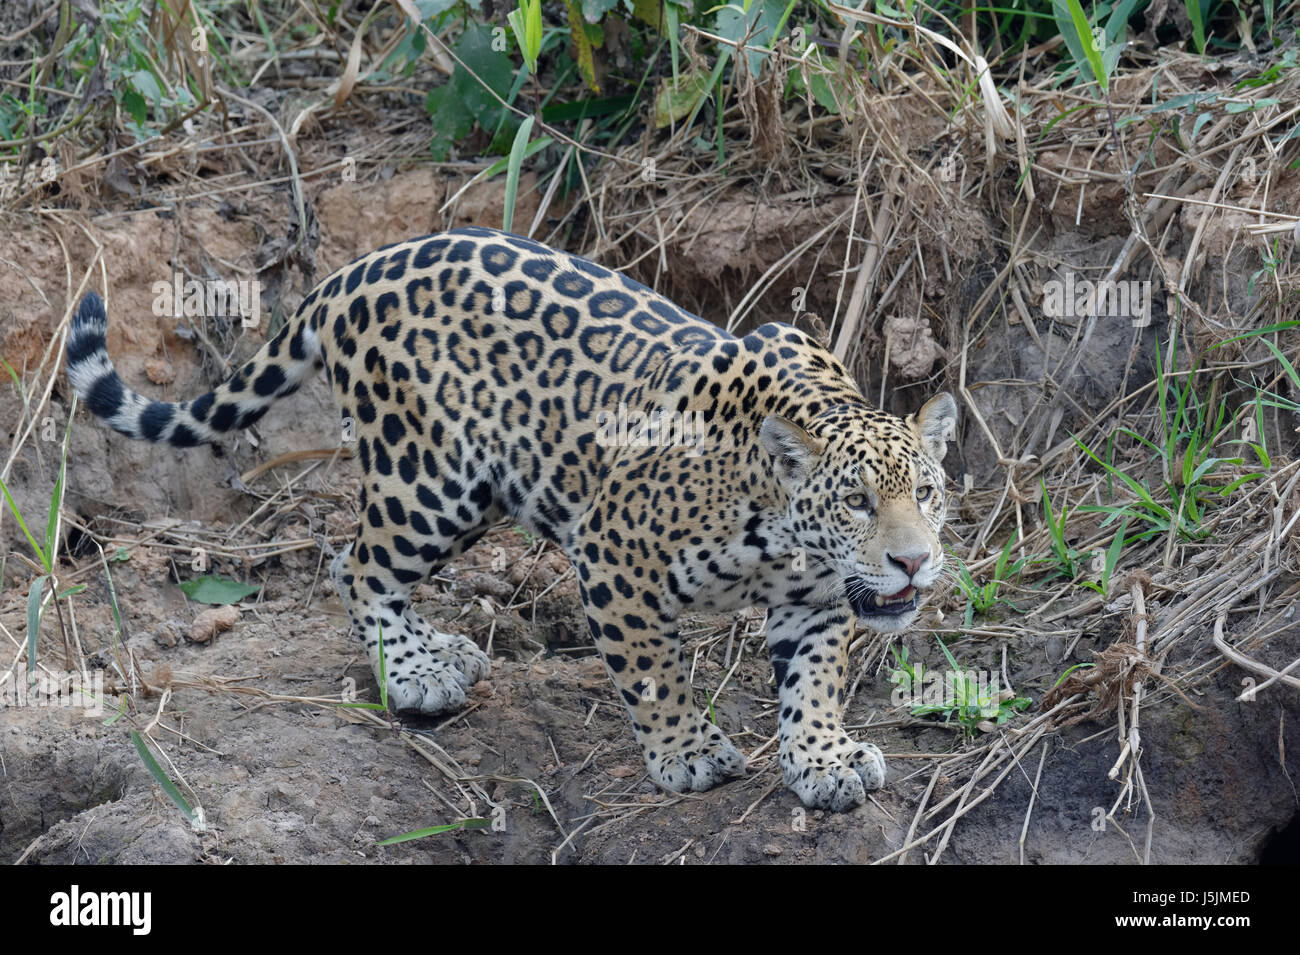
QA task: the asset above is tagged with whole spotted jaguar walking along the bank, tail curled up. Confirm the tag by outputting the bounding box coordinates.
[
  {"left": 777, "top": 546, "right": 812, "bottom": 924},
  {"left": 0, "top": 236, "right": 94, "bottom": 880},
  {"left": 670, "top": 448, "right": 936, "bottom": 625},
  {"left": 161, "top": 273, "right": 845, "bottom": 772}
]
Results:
[{"left": 66, "top": 229, "right": 957, "bottom": 811}]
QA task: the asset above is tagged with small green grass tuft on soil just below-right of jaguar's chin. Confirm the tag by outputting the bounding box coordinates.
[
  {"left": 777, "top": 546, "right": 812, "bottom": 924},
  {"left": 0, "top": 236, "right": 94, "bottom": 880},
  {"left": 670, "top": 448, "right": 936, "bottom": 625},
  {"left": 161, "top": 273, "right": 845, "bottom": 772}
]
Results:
[{"left": 889, "top": 637, "right": 1032, "bottom": 737}]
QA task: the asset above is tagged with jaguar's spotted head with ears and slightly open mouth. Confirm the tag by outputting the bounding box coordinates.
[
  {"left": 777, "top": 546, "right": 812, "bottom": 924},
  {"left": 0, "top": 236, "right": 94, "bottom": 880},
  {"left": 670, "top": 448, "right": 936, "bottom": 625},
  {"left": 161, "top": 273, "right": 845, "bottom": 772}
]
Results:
[{"left": 759, "top": 392, "right": 957, "bottom": 633}]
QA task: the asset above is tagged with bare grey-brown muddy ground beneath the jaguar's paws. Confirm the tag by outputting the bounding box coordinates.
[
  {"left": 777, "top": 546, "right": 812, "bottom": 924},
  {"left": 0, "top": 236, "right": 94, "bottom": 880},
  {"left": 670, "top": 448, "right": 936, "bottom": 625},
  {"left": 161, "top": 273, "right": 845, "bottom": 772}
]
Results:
[{"left": 0, "top": 528, "right": 1300, "bottom": 864}]
